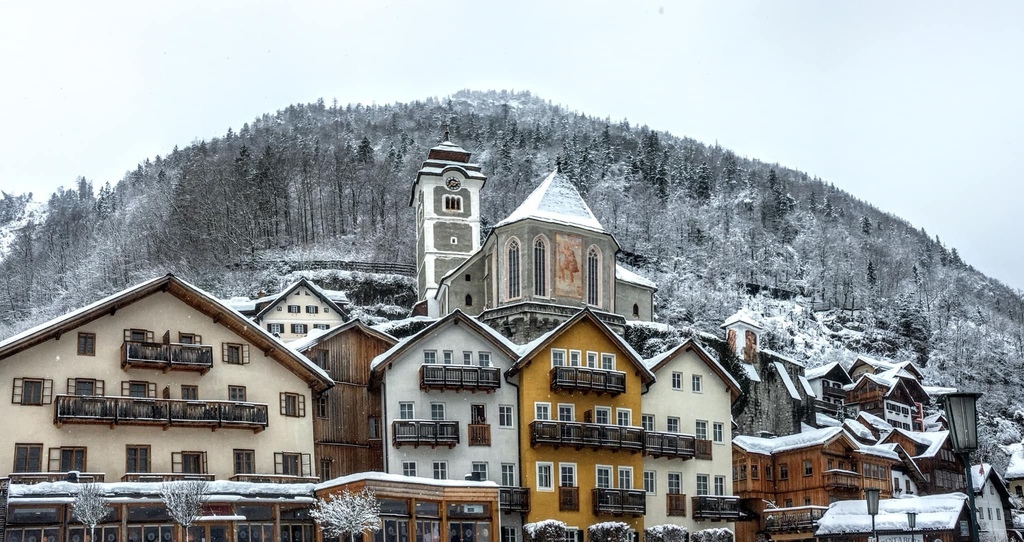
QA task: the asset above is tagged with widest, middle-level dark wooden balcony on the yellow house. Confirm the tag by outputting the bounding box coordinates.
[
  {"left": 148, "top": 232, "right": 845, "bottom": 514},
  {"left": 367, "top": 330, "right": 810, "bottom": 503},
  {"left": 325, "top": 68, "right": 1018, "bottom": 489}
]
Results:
[{"left": 529, "top": 420, "right": 643, "bottom": 452}]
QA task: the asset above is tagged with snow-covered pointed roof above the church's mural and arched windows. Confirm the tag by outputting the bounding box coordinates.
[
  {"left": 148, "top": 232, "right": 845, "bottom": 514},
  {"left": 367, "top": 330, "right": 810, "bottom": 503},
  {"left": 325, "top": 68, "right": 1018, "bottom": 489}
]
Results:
[{"left": 495, "top": 171, "right": 605, "bottom": 234}]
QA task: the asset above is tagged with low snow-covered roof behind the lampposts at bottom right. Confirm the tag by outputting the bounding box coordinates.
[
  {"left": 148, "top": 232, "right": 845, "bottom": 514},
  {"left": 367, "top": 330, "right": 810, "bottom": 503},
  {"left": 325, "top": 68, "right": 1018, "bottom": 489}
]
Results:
[{"left": 814, "top": 493, "right": 967, "bottom": 537}]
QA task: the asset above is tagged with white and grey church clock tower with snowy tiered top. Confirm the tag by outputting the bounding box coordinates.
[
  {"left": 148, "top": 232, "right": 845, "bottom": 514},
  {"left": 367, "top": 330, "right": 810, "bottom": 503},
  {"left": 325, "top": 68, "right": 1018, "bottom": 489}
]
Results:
[{"left": 410, "top": 130, "right": 487, "bottom": 317}]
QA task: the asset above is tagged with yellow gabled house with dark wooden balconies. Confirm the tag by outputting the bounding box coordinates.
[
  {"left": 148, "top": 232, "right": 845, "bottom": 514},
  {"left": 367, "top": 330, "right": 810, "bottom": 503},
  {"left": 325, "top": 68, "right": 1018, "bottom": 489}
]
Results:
[{"left": 506, "top": 308, "right": 654, "bottom": 540}]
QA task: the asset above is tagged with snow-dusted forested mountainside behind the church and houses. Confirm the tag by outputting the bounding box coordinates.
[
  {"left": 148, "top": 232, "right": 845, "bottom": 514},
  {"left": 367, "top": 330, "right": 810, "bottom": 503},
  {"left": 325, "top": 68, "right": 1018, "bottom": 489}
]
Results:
[{"left": 0, "top": 91, "right": 1024, "bottom": 461}]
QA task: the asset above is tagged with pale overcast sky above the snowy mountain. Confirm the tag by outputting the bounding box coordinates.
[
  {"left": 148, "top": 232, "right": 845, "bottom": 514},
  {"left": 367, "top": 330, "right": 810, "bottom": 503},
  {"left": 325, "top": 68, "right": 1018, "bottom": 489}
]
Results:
[{"left": 0, "top": 0, "right": 1024, "bottom": 288}]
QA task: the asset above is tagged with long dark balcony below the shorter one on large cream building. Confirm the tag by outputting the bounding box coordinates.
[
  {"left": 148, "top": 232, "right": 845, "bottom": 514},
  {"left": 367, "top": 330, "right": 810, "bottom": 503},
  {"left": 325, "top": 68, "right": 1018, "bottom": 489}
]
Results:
[{"left": 53, "top": 395, "right": 267, "bottom": 432}]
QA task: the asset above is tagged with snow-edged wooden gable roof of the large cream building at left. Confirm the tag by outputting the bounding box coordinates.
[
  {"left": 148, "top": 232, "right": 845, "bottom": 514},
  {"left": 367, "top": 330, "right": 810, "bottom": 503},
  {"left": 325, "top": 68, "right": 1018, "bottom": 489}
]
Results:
[{"left": 0, "top": 274, "right": 334, "bottom": 391}]
